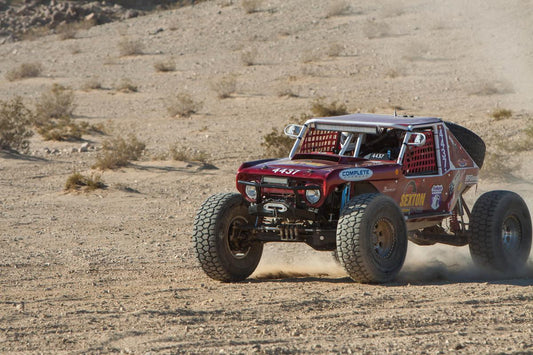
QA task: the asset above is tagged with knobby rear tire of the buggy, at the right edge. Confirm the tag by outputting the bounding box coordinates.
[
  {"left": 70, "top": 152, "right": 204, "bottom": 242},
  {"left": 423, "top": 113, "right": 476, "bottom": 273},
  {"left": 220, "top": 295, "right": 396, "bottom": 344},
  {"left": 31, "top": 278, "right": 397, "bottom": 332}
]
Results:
[{"left": 469, "top": 191, "right": 531, "bottom": 273}]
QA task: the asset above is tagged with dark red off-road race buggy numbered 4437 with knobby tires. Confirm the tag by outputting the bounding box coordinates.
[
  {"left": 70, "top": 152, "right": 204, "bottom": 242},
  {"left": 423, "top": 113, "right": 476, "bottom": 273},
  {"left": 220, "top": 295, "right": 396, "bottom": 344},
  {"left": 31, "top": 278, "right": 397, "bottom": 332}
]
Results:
[{"left": 193, "top": 114, "right": 531, "bottom": 283}]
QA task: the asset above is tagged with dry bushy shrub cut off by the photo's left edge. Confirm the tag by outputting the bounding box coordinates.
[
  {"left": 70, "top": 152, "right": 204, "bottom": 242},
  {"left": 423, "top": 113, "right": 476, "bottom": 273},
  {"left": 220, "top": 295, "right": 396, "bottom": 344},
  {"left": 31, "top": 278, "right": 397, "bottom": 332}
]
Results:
[{"left": 0, "top": 97, "right": 33, "bottom": 152}]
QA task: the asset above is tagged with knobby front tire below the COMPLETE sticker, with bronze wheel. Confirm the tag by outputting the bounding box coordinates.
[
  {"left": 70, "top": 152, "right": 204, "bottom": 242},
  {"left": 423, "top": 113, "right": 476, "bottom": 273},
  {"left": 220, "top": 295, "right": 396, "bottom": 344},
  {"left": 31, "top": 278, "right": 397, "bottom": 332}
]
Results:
[{"left": 337, "top": 193, "right": 407, "bottom": 283}]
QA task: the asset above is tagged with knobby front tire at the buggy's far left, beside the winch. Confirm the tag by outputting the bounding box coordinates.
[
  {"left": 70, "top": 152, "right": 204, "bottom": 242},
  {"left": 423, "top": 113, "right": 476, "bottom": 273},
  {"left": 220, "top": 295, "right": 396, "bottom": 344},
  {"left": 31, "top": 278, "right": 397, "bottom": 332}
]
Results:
[{"left": 192, "top": 193, "right": 263, "bottom": 282}]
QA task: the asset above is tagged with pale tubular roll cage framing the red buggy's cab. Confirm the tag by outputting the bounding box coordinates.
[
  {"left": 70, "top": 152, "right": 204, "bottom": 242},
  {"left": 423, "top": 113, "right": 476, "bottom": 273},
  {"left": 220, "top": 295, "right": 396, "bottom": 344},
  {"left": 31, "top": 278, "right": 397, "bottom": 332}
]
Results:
[{"left": 289, "top": 118, "right": 448, "bottom": 175}]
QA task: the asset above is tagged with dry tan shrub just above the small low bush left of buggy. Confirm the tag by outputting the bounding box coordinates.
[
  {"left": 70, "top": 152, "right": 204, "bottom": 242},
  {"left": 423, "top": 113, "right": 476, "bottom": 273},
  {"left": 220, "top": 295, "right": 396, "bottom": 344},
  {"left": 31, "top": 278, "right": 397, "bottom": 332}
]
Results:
[{"left": 93, "top": 134, "right": 146, "bottom": 170}]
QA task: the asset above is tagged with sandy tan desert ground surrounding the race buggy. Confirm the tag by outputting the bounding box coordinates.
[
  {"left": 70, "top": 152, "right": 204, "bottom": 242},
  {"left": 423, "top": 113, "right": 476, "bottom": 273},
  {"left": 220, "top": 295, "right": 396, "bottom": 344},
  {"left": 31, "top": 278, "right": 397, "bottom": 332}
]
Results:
[{"left": 0, "top": 0, "right": 533, "bottom": 354}]
